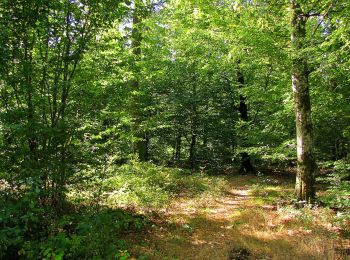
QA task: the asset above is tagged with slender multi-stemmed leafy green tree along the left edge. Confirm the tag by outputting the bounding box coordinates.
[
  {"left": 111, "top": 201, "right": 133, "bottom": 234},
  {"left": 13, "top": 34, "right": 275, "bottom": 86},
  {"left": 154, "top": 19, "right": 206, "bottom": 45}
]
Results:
[{"left": 0, "top": 0, "right": 123, "bottom": 207}]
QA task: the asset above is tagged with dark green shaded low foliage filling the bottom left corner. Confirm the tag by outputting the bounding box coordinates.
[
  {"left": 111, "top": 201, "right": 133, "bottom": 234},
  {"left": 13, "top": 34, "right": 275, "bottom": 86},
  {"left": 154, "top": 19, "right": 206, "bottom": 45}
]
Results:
[{"left": 0, "top": 196, "right": 148, "bottom": 259}]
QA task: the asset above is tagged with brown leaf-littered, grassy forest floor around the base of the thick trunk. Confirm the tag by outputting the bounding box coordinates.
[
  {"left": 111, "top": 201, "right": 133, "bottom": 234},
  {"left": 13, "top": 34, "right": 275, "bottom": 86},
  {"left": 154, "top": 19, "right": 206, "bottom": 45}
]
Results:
[{"left": 126, "top": 176, "right": 350, "bottom": 259}]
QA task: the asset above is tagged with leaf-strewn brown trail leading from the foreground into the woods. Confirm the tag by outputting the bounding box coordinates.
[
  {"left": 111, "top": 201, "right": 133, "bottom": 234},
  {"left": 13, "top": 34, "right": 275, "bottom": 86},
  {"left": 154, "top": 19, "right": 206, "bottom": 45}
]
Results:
[{"left": 130, "top": 176, "right": 270, "bottom": 259}]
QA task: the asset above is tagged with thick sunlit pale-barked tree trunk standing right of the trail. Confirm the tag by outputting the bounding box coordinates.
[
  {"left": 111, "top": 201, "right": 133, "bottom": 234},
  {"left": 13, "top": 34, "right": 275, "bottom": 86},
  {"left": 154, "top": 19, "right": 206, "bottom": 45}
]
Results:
[{"left": 291, "top": 0, "right": 316, "bottom": 202}]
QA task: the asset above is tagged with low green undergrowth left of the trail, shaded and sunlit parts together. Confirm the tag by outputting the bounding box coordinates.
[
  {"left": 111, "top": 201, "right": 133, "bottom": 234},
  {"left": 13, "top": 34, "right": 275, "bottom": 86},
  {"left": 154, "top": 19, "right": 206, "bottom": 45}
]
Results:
[{"left": 0, "top": 162, "right": 225, "bottom": 260}]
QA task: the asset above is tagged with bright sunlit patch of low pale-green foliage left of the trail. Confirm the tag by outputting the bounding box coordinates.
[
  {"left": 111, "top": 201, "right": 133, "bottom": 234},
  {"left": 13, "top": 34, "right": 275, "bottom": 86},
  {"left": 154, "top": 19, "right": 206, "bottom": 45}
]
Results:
[{"left": 69, "top": 162, "right": 225, "bottom": 209}]
